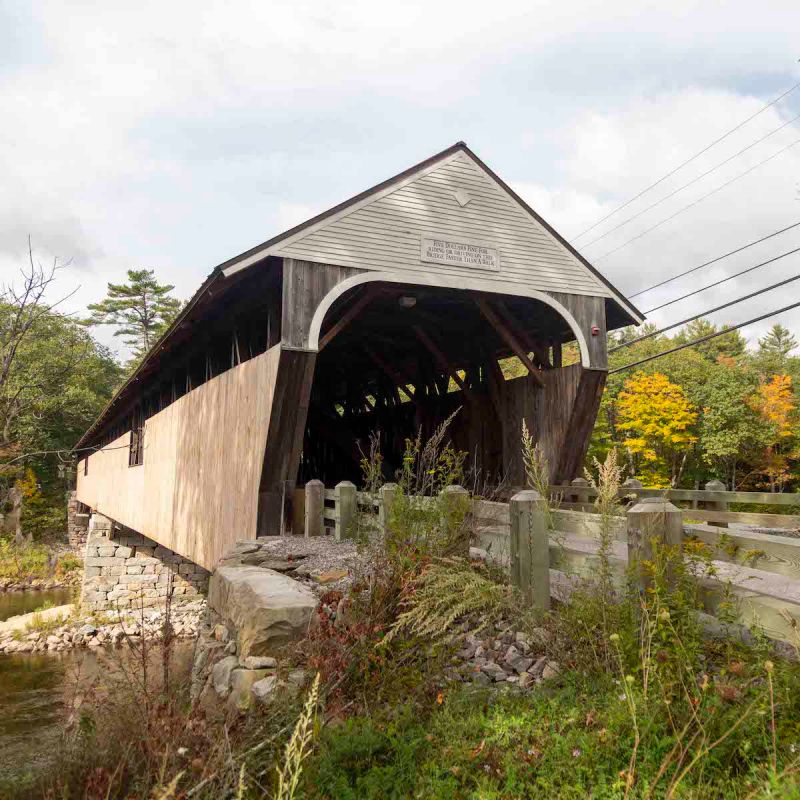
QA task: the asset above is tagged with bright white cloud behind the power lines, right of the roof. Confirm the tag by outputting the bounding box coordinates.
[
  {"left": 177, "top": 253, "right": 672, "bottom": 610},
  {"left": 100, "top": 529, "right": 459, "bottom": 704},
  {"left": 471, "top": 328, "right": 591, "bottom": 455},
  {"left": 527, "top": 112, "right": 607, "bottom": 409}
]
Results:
[{"left": 516, "top": 88, "right": 800, "bottom": 343}]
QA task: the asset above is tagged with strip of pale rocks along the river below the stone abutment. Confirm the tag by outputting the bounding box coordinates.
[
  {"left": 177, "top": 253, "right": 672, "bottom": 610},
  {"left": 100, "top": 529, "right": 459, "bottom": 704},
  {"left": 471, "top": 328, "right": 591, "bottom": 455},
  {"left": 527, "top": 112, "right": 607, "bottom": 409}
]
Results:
[{"left": 0, "top": 600, "right": 206, "bottom": 655}]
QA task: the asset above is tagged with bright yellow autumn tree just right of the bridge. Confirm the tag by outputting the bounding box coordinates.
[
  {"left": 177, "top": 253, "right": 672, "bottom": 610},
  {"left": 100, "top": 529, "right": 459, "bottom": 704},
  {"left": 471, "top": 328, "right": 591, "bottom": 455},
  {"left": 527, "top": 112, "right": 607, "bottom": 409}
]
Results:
[{"left": 617, "top": 372, "right": 697, "bottom": 487}]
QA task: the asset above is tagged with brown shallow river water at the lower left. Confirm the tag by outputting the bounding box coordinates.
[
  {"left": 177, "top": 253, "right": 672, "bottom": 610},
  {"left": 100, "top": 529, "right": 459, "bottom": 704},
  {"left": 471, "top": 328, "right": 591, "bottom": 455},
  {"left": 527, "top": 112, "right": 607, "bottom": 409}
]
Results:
[{"left": 0, "top": 589, "right": 193, "bottom": 797}]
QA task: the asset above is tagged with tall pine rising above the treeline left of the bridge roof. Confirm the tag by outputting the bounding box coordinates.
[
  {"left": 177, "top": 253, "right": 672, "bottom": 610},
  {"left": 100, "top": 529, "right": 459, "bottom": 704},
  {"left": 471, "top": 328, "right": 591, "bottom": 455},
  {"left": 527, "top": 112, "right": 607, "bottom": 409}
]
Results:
[{"left": 86, "top": 269, "right": 181, "bottom": 362}]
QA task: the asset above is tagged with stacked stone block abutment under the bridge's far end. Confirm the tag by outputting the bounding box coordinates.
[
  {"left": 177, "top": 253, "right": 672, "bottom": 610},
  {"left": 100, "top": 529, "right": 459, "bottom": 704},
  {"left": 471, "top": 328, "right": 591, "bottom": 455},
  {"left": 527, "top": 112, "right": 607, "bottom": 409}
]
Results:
[{"left": 81, "top": 514, "right": 209, "bottom": 611}]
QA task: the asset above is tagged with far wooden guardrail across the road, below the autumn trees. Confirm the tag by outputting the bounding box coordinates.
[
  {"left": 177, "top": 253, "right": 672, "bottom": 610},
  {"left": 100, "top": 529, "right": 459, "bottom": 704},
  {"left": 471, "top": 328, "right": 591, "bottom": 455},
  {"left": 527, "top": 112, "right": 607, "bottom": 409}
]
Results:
[{"left": 550, "top": 478, "right": 800, "bottom": 534}]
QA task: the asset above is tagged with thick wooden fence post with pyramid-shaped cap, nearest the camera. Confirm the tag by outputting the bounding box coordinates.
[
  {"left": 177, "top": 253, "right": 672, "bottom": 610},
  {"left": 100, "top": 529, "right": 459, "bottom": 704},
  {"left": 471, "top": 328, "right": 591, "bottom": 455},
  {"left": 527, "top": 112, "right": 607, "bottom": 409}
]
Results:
[{"left": 628, "top": 497, "right": 683, "bottom": 589}]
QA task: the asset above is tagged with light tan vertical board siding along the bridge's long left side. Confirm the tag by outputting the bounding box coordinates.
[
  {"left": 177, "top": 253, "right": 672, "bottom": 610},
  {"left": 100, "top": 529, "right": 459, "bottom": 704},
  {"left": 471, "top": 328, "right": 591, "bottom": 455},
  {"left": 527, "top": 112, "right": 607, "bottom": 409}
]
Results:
[{"left": 77, "top": 346, "right": 280, "bottom": 569}]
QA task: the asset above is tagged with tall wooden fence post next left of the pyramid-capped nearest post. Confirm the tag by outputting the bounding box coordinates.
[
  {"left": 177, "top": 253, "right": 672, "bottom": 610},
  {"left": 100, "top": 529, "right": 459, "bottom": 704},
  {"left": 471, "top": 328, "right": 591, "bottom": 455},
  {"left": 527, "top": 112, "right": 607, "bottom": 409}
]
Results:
[{"left": 508, "top": 489, "right": 550, "bottom": 611}]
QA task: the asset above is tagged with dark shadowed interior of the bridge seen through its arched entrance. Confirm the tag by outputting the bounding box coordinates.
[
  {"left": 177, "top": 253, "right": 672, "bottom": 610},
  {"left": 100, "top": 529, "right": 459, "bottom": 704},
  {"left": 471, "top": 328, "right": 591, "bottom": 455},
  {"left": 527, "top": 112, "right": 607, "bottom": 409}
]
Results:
[{"left": 298, "top": 284, "right": 579, "bottom": 485}]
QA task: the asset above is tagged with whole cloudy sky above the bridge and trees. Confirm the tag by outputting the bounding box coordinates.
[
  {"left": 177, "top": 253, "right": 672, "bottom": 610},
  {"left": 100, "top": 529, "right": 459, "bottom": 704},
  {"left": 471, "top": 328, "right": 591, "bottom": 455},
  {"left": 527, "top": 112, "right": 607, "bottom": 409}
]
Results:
[{"left": 0, "top": 0, "right": 800, "bottom": 355}]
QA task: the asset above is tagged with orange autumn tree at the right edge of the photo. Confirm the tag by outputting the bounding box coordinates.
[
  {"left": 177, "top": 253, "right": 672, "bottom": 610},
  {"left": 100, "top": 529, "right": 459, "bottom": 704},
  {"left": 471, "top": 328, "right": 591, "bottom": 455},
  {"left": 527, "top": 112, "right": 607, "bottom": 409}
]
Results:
[{"left": 751, "top": 375, "right": 797, "bottom": 492}]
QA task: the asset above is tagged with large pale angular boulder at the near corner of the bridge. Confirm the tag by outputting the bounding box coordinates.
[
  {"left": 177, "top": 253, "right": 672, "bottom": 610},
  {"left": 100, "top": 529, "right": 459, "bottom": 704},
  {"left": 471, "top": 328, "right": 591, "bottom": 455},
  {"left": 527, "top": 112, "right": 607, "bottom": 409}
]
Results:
[{"left": 208, "top": 564, "right": 318, "bottom": 659}]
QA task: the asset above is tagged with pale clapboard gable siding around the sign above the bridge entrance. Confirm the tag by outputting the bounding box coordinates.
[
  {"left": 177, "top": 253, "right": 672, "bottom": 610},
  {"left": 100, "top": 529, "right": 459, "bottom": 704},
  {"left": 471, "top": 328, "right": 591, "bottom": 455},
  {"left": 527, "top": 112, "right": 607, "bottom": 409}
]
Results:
[{"left": 270, "top": 152, "right": 611, "bottom": 297}]
